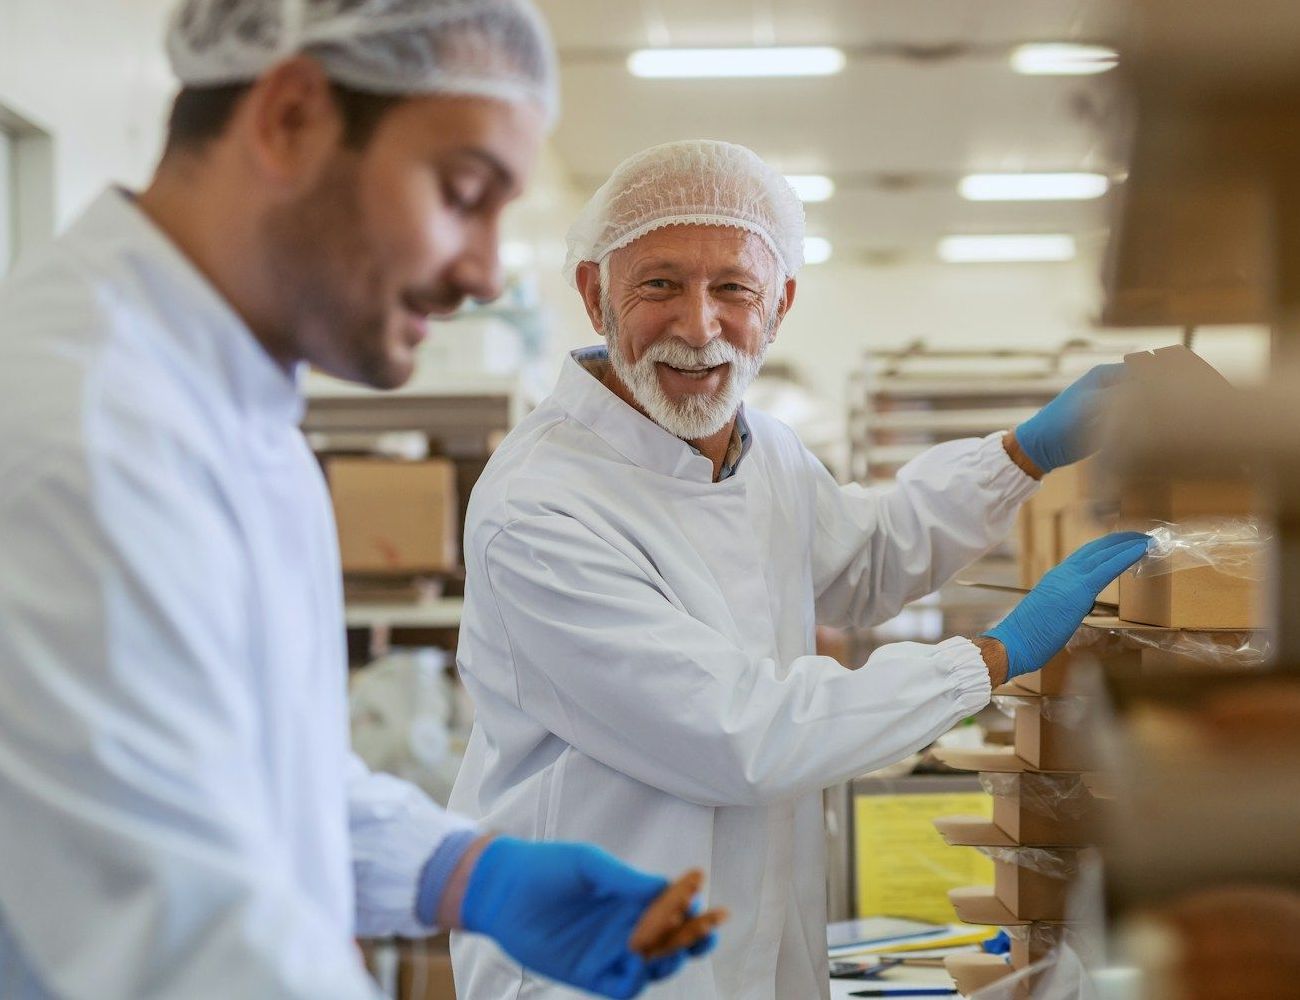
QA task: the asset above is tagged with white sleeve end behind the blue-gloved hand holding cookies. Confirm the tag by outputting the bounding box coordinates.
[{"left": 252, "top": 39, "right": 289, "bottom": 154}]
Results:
[{"left": 347, "top": 754, "right": 476, "bottom": 938}]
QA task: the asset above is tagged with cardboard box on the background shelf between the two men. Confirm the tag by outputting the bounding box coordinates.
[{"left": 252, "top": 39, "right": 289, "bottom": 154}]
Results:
[{"left": 325, "top": 458, "right": 460, "bottom": 575}]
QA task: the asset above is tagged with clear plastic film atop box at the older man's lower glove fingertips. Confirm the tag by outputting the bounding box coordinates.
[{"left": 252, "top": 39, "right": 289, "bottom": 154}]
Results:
[{"left": 1134, "top": 518, "right": 1273, "bottom": 580}]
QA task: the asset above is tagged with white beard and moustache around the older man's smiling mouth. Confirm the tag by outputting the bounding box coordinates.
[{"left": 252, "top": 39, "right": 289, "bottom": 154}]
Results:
[{"left": 605, "top": 301, "right": 768, "bottom": 441}]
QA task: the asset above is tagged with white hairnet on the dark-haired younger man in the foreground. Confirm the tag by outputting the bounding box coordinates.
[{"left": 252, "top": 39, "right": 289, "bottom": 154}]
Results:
[{"left": 166, "top": 0, "right": 559, "bottom": 121}]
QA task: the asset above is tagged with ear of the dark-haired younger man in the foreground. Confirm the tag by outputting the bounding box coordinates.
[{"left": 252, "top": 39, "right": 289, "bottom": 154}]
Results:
[{"left": 237, "top": 56, "right": 343, "bottom": 189}]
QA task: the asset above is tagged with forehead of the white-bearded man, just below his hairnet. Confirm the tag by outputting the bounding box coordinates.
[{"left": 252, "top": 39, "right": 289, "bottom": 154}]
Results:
[{"left": 607, "top": 224, "right": 777, "bottom": 283}]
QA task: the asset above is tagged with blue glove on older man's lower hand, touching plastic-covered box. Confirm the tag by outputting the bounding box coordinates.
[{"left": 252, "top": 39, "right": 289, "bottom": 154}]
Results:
[{"left": 984, "top": 532, "right": 1151, "bottom": 680}]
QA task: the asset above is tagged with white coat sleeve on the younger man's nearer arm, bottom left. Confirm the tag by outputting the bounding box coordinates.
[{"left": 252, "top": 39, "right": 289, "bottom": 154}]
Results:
[{"left": 0, "top": 421, "right": 378, "bottom": 1000}]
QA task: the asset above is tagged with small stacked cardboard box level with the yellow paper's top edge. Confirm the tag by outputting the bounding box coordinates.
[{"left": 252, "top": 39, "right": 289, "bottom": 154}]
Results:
[{"left": 993, "top": 771, "right": 1099, "bottom": 847}]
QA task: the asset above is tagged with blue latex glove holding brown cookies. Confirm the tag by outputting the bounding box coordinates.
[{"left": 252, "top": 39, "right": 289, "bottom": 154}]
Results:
[{"left": 460, "top": 837, "right": 716, "bottom": 997}]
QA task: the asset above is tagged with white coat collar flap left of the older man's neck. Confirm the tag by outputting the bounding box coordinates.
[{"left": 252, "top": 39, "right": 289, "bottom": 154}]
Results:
[{"left": 551, "top": 347, "right": 744, "bottom": 485}]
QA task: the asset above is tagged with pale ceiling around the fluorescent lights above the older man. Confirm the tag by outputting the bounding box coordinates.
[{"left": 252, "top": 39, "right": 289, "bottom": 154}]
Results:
[{"left": 538, "top": 0, "right": 1117, "bottom": 264}]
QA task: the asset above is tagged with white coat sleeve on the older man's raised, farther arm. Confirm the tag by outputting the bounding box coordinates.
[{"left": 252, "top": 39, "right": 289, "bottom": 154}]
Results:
[{"left": 807, "top": 433, "right": 1037, "bottom": 628}]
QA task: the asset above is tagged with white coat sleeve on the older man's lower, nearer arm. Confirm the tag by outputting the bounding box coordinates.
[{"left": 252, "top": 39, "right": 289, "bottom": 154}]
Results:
[{"left": 478, "top": 514, "right": 989, "bottom": 806}]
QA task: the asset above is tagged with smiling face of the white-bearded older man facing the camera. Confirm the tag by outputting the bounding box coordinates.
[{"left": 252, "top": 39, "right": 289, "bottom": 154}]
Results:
[{"left": 577, "top": 225, "right": 794, "bottom": 441}]
